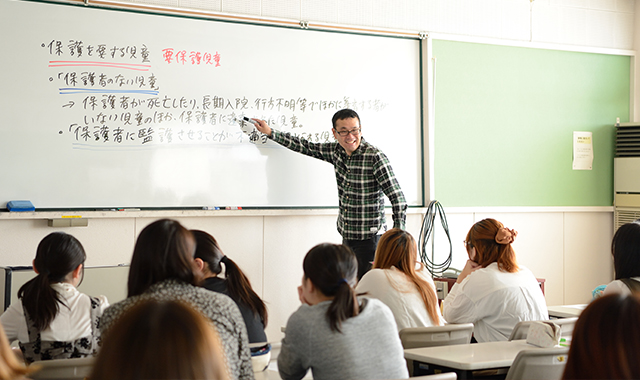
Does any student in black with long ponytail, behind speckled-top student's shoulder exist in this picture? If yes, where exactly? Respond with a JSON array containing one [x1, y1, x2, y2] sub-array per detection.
[[191, 230, 267, 343]]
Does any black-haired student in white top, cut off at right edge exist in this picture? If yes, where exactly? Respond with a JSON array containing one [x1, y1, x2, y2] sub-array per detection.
[[603, 222, 640, 295]]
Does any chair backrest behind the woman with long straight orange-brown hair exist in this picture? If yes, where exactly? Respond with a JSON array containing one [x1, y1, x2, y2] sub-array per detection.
[[400, 323, 473, 348]]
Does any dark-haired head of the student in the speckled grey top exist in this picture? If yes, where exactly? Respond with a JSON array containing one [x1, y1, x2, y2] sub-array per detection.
[[128, 219, 200, 297]]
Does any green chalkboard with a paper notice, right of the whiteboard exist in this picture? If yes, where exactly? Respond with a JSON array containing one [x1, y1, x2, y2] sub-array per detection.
[[433, 40, 630, 207]]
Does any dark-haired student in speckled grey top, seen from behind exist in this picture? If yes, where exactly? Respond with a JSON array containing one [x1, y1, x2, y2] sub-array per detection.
[[100, 219, 253, 379]]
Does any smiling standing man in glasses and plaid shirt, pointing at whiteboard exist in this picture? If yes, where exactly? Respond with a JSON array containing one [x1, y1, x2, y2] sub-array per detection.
[[253, 109, 407, 279]]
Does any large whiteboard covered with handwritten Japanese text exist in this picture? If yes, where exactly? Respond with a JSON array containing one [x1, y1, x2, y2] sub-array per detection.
[[0, 0, 423, 209]]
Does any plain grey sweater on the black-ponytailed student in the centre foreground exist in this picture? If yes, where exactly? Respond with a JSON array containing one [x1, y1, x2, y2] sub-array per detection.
[[278, 298, 409, 380]]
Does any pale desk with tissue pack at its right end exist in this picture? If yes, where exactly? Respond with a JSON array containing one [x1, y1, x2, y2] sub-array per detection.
[[404, 340, 543, 379]]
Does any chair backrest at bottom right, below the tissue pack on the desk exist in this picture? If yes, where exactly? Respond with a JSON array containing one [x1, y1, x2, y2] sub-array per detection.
[[505, 347, 569, 380]]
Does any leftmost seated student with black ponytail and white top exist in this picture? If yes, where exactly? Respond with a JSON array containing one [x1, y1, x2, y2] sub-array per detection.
[[0, 232, 109, 363]]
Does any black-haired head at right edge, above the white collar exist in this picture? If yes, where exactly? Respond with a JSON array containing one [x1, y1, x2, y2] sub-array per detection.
[[611, 221, 640, 280]]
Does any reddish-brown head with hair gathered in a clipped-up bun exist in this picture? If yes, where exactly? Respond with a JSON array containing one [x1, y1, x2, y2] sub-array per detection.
[[465, 219, 518, 273]]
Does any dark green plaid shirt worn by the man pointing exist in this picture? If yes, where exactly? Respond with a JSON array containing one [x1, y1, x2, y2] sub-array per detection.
[[271, 130, 407, 240]]
